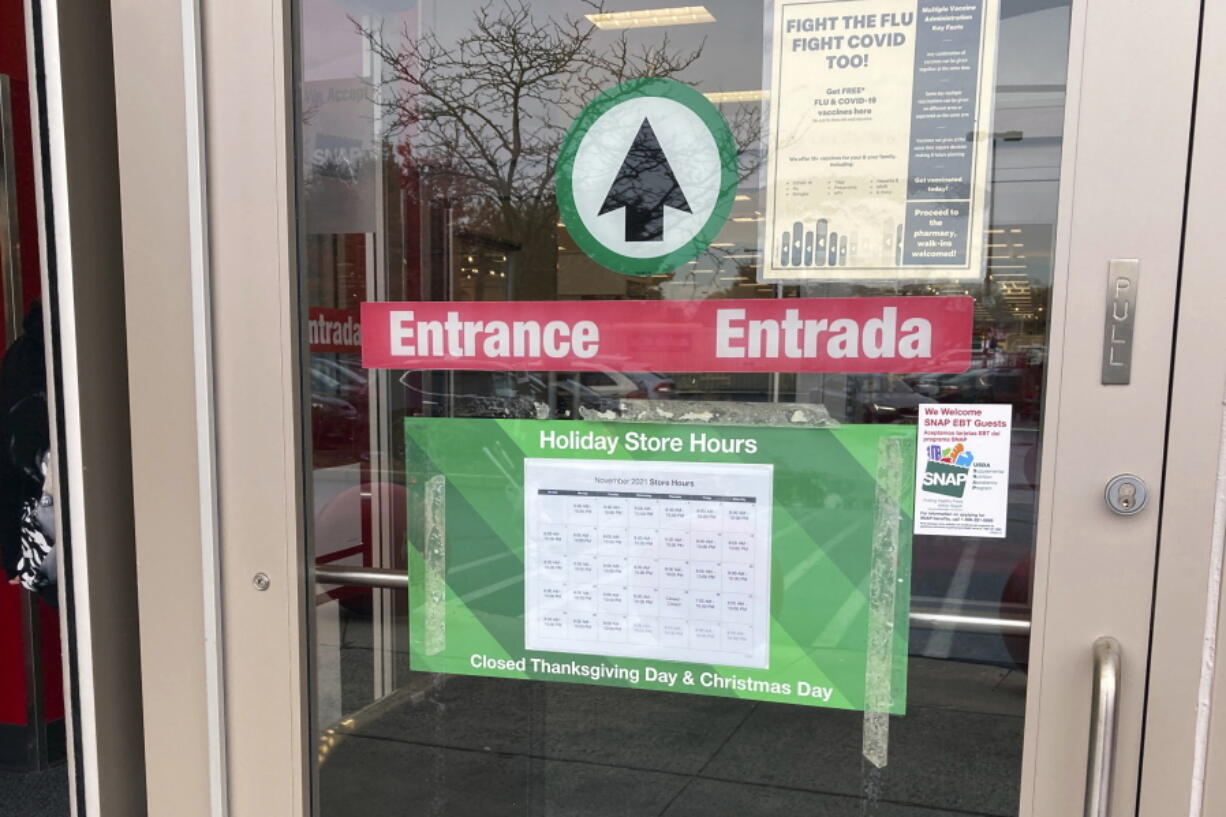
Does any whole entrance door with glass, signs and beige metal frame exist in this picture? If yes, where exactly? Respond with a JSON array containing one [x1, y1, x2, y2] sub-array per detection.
[[198, 0, 1197, 817]]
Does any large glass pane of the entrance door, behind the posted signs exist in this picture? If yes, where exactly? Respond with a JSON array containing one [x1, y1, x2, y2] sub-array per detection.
[[299, 0, 1054, 815]]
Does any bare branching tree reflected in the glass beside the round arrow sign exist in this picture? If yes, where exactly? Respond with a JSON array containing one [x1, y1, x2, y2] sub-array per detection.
[[354, 0, 758, 298]]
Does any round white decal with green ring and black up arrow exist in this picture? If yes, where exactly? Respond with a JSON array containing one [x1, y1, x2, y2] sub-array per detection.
[[558, 79, 737, 275]]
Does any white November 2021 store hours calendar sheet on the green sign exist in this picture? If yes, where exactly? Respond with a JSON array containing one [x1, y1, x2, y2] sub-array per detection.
[[524, 458, 774, 669]]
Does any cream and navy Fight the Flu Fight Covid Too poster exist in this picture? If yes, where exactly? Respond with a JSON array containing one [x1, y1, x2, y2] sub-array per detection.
[[759, 0, 998, 282]]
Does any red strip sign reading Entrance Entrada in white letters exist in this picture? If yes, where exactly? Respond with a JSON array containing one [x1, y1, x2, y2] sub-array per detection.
[[362, 297, 975, 373]]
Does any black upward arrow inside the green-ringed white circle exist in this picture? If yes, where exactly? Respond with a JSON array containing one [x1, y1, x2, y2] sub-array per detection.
[[600, 119, 691, 242]]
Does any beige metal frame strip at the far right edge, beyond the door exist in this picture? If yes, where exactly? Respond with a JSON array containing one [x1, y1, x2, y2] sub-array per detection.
[[1139, 0, 1226, 817]]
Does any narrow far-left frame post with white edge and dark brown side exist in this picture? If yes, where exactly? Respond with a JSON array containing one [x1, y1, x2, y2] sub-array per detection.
[[25, 0, 145, 817]]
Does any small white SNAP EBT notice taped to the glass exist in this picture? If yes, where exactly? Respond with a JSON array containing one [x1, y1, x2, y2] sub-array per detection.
[[915, 404, 1013, 539]]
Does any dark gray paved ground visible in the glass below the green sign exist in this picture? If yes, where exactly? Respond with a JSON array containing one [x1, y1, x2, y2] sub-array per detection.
[[320, 659, 1025, 817]]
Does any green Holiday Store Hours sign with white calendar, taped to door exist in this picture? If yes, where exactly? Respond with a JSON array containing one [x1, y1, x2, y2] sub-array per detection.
[[405, 418, 915, 714]]
